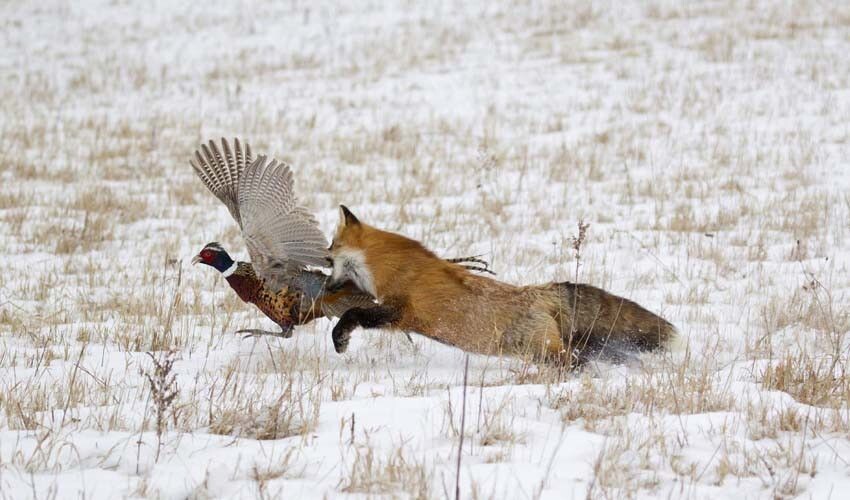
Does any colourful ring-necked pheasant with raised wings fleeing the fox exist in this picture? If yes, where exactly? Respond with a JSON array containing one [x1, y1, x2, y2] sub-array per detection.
[[190, 139, 492, 338]]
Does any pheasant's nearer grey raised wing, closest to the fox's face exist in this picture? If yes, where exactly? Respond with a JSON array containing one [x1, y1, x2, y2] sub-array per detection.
[[236, 155, 328, 291]]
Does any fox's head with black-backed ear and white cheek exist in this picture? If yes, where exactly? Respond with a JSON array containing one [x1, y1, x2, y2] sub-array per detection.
[[327, 205, 378, 298]]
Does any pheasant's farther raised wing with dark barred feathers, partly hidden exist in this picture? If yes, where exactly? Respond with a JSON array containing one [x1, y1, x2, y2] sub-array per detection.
[[189, 138, 253, 228]]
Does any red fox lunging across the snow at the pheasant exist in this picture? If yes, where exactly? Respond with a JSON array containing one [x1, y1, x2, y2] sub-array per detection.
[[328, 205, 676, 366]]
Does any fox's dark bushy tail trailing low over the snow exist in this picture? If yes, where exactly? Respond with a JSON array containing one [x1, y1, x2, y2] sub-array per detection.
[[557, 282, 677, 360]]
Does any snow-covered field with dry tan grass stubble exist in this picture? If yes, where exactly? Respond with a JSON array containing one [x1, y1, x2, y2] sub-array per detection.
[[0, 0, 850, 499]]
